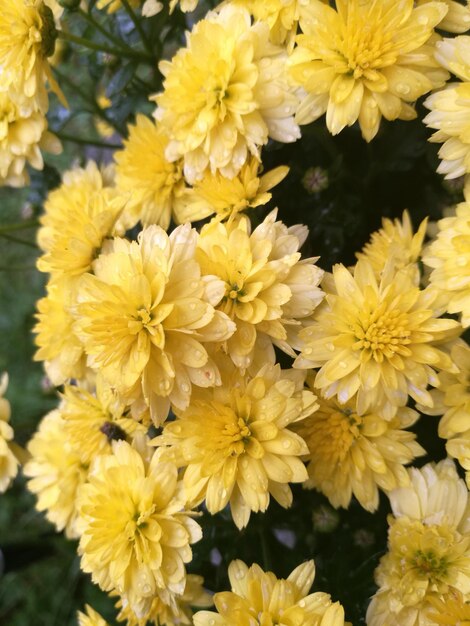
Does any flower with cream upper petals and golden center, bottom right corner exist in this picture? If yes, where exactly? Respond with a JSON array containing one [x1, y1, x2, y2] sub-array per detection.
[[366, 460, 470, 626]]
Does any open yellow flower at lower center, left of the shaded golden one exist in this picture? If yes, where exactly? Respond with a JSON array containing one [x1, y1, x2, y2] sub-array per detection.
[[152, 364, 317, 528]]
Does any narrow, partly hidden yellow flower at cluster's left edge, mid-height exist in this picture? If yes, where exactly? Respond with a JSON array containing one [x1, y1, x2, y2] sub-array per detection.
[[33, 279, 85, 385]]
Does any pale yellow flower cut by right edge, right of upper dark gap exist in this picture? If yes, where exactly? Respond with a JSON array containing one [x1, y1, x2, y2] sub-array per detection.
[[423, 36, 470, 178]]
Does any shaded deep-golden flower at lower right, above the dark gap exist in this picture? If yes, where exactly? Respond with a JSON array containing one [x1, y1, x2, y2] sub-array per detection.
[[295, 372, 426, 511]]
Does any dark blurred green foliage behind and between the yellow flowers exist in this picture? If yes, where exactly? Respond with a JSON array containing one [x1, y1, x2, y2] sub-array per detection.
[[0, 2, 459, 626]]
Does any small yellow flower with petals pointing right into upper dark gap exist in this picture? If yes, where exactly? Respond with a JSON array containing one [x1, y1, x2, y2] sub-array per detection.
[[175, 157, 289, 222]]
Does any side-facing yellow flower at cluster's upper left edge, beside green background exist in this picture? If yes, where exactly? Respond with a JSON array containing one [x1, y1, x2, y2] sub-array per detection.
[[37, 161, 115, 254]]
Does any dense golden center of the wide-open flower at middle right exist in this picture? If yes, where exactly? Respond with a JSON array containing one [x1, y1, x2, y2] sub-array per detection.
[[353, 310, 411, 362]]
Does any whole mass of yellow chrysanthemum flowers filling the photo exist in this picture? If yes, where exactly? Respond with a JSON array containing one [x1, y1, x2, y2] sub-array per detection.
[[0, 0, 470, 626]]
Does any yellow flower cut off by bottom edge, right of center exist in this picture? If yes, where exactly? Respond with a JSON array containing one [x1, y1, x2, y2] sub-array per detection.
[[194, 561, 348, 626]]
